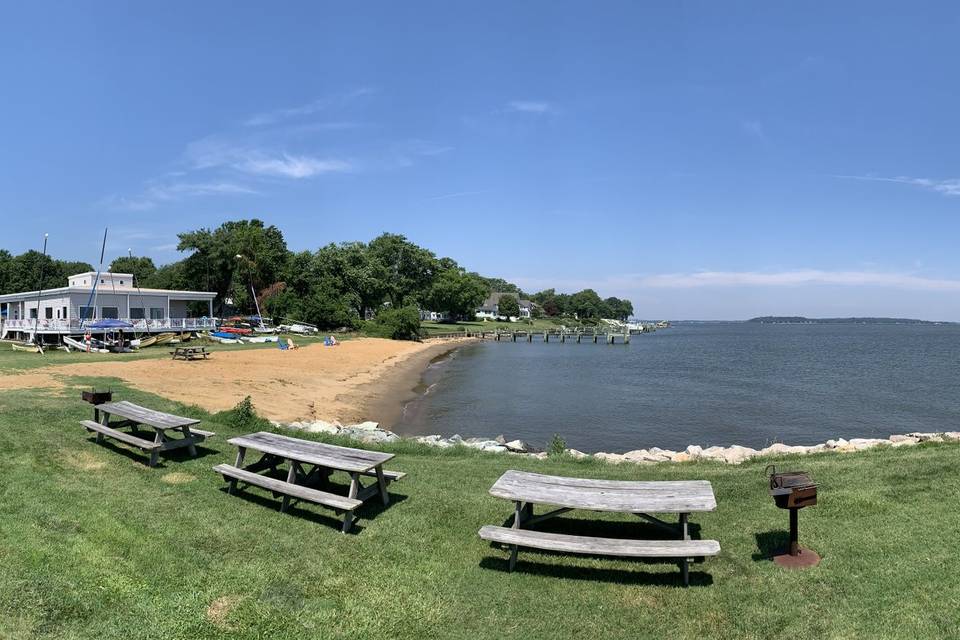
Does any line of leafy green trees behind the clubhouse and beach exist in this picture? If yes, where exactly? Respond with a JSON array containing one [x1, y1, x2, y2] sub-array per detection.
[[0, 219, 633, 329]]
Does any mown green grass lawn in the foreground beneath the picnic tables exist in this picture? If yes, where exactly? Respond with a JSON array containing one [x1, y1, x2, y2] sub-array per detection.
[[0, 378, 960, 640]]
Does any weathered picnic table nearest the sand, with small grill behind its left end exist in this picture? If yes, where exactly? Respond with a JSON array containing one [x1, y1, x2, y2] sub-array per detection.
[[80, 401, 216, 467]]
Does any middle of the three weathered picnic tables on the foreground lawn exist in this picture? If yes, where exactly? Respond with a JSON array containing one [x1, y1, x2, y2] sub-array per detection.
[[213, 431, 406, 533]]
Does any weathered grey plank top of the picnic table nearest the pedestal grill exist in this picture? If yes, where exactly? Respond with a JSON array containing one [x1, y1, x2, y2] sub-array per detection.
[[490, 470, 717, 513]]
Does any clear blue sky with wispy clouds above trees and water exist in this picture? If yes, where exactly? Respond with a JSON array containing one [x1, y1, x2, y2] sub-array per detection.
[[0, 1, 960, 320]]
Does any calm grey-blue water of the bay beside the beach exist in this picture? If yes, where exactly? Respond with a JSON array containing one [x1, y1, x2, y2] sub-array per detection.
[[395, 323, 960, 452]]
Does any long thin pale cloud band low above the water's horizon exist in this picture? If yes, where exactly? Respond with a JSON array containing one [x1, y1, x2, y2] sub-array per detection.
[[626, 269, 960, 291]]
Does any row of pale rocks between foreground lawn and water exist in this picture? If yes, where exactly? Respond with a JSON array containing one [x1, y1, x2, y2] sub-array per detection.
[[273, 420, 960, 464]]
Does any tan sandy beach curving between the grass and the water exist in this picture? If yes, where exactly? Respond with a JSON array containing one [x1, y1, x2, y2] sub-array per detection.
[[0, 338, 472, 425]]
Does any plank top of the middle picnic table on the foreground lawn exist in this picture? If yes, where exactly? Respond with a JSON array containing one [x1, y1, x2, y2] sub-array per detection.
[[227, 431, 393, 473]]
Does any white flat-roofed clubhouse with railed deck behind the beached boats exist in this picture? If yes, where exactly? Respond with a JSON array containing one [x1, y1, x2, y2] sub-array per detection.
[[0, 271, 217, 342]]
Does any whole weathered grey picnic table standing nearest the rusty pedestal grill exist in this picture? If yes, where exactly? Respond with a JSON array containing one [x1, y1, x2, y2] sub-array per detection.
[[480, 470, 720, 586]]
